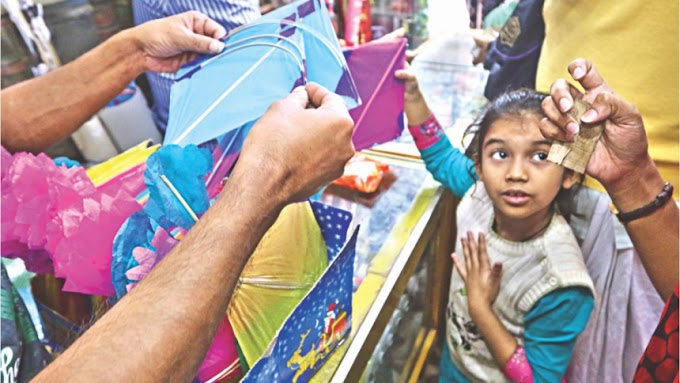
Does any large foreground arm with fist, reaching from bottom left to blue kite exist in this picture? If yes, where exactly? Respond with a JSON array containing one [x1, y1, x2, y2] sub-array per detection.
[[30, 84, 354, 382]]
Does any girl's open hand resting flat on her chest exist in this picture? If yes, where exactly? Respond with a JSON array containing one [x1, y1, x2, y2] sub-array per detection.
[[451, 231, 503, 320]]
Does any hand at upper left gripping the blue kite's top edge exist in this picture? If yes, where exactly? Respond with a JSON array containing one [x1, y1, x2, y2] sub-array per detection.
[[125, 11, 226, 72]]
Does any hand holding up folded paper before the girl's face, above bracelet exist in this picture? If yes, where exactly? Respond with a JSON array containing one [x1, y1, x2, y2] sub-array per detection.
[[541, 59, 660, 190]]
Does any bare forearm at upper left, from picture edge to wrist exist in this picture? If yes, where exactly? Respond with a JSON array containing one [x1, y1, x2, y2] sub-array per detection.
[[2, 31, 144, 152]]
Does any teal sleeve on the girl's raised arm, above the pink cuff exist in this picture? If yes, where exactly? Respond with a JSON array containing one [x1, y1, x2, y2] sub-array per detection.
[[420, 135, 477, 197]]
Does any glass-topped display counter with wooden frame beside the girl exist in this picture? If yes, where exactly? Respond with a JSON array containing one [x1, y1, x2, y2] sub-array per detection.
[[306, 34, 488, 383]]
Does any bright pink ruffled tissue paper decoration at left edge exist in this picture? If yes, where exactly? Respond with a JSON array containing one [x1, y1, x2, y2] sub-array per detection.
[[0, 148, 141, 296]]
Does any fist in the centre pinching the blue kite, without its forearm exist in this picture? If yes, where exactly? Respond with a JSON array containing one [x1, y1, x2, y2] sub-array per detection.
[[230, 83, 354, 204]]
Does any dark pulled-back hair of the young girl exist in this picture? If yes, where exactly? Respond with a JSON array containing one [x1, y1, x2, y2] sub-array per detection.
[[463, 88, 583, 219]]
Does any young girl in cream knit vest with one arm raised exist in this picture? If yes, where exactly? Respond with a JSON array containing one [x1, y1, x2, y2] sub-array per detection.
[[396, 70, 593, 382]]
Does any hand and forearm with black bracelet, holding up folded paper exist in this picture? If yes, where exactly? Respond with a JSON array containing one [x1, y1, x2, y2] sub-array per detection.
[[541, 59, 680, 300]]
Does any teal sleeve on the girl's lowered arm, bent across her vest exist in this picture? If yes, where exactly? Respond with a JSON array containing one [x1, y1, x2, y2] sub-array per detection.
[[524, 287, 594, 383]]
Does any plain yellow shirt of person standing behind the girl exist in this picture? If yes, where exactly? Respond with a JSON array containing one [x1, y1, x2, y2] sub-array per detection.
[[536, 0, 680, 192]]
